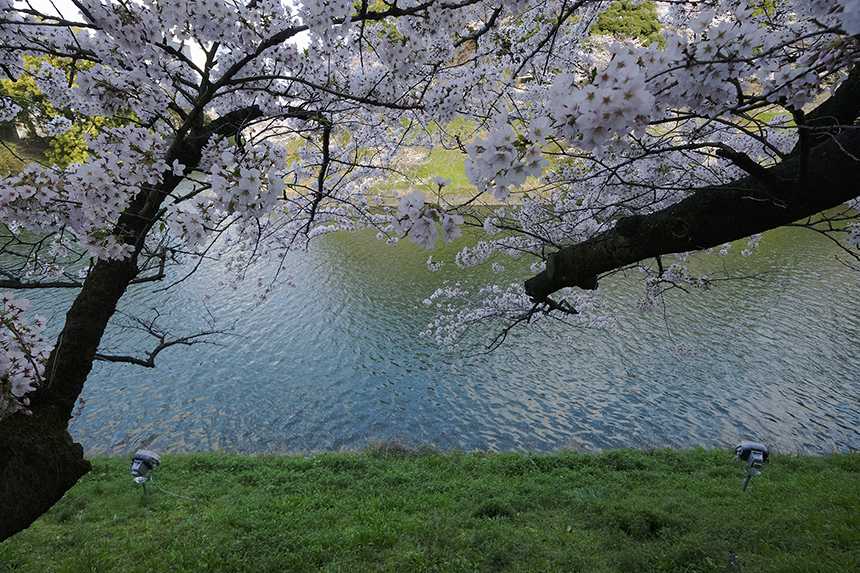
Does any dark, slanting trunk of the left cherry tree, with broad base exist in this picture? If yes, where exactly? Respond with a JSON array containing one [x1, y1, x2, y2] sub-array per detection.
[[0, 104, 262, 541]]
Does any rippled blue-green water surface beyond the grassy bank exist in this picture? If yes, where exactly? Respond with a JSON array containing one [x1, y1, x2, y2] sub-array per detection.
[[26, 226, 860, 454]]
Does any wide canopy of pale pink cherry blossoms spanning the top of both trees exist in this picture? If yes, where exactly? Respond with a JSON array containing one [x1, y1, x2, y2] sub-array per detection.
[[0, 0, 860, 386]]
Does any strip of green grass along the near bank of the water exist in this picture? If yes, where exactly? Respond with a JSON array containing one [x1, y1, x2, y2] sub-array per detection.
[[0, 444, 860, 573]]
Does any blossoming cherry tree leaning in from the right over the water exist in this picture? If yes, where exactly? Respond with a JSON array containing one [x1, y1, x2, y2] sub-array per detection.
[[412, 2, 860, 352]]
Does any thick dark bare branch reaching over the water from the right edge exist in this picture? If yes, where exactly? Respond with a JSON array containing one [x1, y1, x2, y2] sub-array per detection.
[[525, 128, 860, 302]]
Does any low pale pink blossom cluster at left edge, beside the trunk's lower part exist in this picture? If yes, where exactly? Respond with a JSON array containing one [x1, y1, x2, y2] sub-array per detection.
[[0, 293, 53, 420]]
